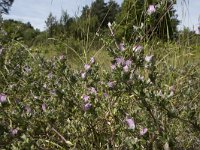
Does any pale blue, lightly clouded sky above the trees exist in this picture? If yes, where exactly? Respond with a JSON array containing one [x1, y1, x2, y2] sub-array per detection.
[[3, 0, 200, 32]]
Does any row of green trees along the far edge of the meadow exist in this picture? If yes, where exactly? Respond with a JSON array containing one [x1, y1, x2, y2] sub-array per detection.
[[0, 0, 198, 46]]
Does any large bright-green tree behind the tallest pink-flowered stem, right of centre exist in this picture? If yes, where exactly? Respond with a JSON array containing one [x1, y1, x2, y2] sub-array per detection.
[[117, 0, 179, 40]]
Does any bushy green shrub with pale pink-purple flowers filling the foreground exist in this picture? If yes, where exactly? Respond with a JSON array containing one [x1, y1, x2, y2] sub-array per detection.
[[0, 2, 200, 150]]
